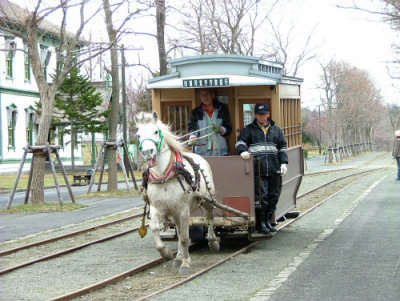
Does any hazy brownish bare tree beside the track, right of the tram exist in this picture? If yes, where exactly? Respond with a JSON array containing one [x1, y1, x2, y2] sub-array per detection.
[[320, 61, 382, 146]]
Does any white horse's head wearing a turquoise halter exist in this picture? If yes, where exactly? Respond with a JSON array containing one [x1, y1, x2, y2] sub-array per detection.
[[135, 112, 163, 167]]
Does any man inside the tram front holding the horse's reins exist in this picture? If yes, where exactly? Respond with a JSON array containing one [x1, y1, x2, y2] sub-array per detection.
[[188, 88, 232, 156]]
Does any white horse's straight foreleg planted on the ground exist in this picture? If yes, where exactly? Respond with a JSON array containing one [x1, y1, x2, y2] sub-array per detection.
[[177, 208, 190, 276]]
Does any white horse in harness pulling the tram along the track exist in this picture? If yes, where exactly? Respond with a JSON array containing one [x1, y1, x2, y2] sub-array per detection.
[[135, 113, 219, 275]]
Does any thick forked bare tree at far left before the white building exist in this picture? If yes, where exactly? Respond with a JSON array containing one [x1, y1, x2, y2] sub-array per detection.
[[0, 0, 103, 204]]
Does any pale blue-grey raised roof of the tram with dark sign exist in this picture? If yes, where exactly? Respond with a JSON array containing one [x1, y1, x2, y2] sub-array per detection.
[[147, 54, 303, 89]]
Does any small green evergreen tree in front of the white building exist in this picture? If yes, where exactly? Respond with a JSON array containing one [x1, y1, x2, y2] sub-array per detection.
[[54, 68, 109, 170]]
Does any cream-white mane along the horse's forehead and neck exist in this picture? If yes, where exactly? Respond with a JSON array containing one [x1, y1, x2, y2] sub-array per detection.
[[136, 112, 184, 153]]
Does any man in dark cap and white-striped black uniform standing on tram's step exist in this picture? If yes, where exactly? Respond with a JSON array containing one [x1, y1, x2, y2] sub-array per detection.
[[235, 104, 288, 235]]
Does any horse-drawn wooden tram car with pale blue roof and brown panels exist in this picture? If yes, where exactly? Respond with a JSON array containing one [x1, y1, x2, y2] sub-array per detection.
[[147, 54, 304, 240]]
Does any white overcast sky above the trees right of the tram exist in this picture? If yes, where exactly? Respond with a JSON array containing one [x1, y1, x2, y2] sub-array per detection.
[[284, 0, 400, 107]]
